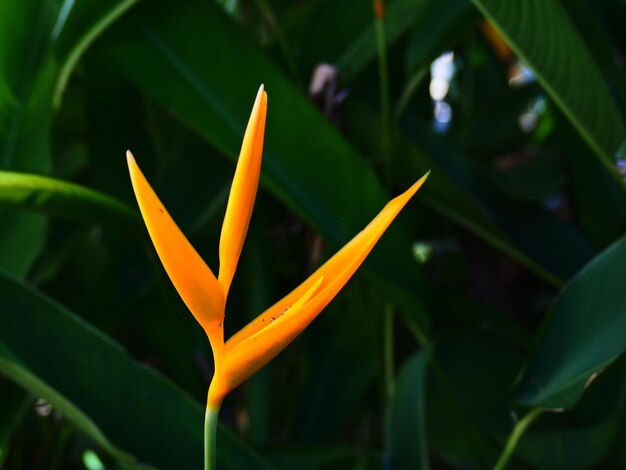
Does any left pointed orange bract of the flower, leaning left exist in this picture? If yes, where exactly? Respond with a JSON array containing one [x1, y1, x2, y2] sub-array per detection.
[[126, 151, 224, 356]]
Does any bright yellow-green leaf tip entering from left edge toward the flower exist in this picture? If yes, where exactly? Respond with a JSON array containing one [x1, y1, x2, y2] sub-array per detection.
[[0, 171, 143, 234]]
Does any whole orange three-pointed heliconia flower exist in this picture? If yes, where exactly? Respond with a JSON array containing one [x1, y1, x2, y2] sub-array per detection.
[[127, 85, 428, 410]]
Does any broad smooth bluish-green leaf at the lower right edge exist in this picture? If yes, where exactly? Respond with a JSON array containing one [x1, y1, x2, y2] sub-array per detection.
[[515, 238, 626, 408]]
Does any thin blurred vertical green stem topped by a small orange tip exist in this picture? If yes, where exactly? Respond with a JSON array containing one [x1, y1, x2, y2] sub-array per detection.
[[374, 2, 393, 185]]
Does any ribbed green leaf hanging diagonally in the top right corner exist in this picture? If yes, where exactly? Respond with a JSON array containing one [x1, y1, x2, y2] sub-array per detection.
[[472, 0, 626, 188]]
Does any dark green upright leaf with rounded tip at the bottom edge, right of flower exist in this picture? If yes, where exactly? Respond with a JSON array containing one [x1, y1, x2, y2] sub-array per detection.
[[385, 350, 430, 469]]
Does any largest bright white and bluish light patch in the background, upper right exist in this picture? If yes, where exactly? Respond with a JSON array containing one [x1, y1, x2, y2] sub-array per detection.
[[428, 51, 456, 133]]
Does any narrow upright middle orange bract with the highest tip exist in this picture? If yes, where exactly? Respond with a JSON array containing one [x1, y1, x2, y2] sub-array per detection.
[[218, 85, 267, 298]]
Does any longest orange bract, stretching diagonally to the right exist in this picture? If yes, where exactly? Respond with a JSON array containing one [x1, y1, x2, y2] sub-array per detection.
[[214, 173, 428, 396]]
